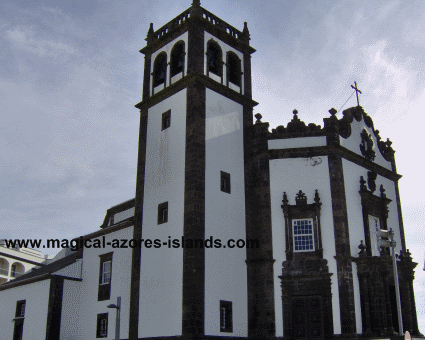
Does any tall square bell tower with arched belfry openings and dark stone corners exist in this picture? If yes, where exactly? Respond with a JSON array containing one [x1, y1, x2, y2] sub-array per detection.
[[129, 0, 274, 339]]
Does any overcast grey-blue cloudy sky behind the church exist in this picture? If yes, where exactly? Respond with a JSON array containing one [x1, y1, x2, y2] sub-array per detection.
[[0, 0, 425, 333]]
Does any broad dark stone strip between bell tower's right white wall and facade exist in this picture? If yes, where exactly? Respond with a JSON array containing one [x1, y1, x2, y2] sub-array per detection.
[[244, 119, 276, 339]]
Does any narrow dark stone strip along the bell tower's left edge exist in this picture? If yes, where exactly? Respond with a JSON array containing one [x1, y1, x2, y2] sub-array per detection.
[[128, 108, 148, 339]]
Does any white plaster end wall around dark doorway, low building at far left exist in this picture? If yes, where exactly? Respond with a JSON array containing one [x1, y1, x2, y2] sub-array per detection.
[[0, 279, 50, 340]]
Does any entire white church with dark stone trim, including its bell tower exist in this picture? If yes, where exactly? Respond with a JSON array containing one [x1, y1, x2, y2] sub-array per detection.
[[0, 0, 423, 340]]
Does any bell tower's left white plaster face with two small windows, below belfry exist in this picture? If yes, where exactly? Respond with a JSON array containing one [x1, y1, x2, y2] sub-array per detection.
[[139, 89, 187, 337]]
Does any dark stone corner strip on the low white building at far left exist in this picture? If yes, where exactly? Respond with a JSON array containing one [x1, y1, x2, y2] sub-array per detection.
[[46, 276, 64, 340]]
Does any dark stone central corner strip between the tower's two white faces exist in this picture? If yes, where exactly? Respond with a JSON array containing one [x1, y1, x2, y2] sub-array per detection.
[[182, 82, 206, 338]]
